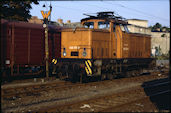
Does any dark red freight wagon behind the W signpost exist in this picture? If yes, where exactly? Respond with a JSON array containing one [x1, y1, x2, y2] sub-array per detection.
[[0, 19, 61, 78]]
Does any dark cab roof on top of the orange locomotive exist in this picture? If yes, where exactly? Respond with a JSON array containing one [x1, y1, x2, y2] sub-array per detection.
[[81, 11, 128, 24]]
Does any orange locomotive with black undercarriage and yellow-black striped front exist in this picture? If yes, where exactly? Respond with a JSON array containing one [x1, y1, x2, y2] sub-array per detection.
[[54, 12, 154, 81]]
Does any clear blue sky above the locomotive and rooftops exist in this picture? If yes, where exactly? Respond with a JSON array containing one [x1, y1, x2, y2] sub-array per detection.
[[30, 0, 170, 27]]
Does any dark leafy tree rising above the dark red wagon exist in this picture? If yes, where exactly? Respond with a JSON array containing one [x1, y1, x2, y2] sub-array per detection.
[[0, 0, 39, 21]]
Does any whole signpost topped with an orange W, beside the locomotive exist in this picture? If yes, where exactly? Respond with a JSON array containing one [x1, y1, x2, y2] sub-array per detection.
[[41, 7, 51, 79]]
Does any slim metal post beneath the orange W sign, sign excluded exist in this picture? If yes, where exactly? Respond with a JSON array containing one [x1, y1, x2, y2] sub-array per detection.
[[45, 21, 49, 79]]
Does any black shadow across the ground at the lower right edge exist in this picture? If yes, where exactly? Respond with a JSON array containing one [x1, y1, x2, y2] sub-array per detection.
[[142, 78, 171, 111]]
